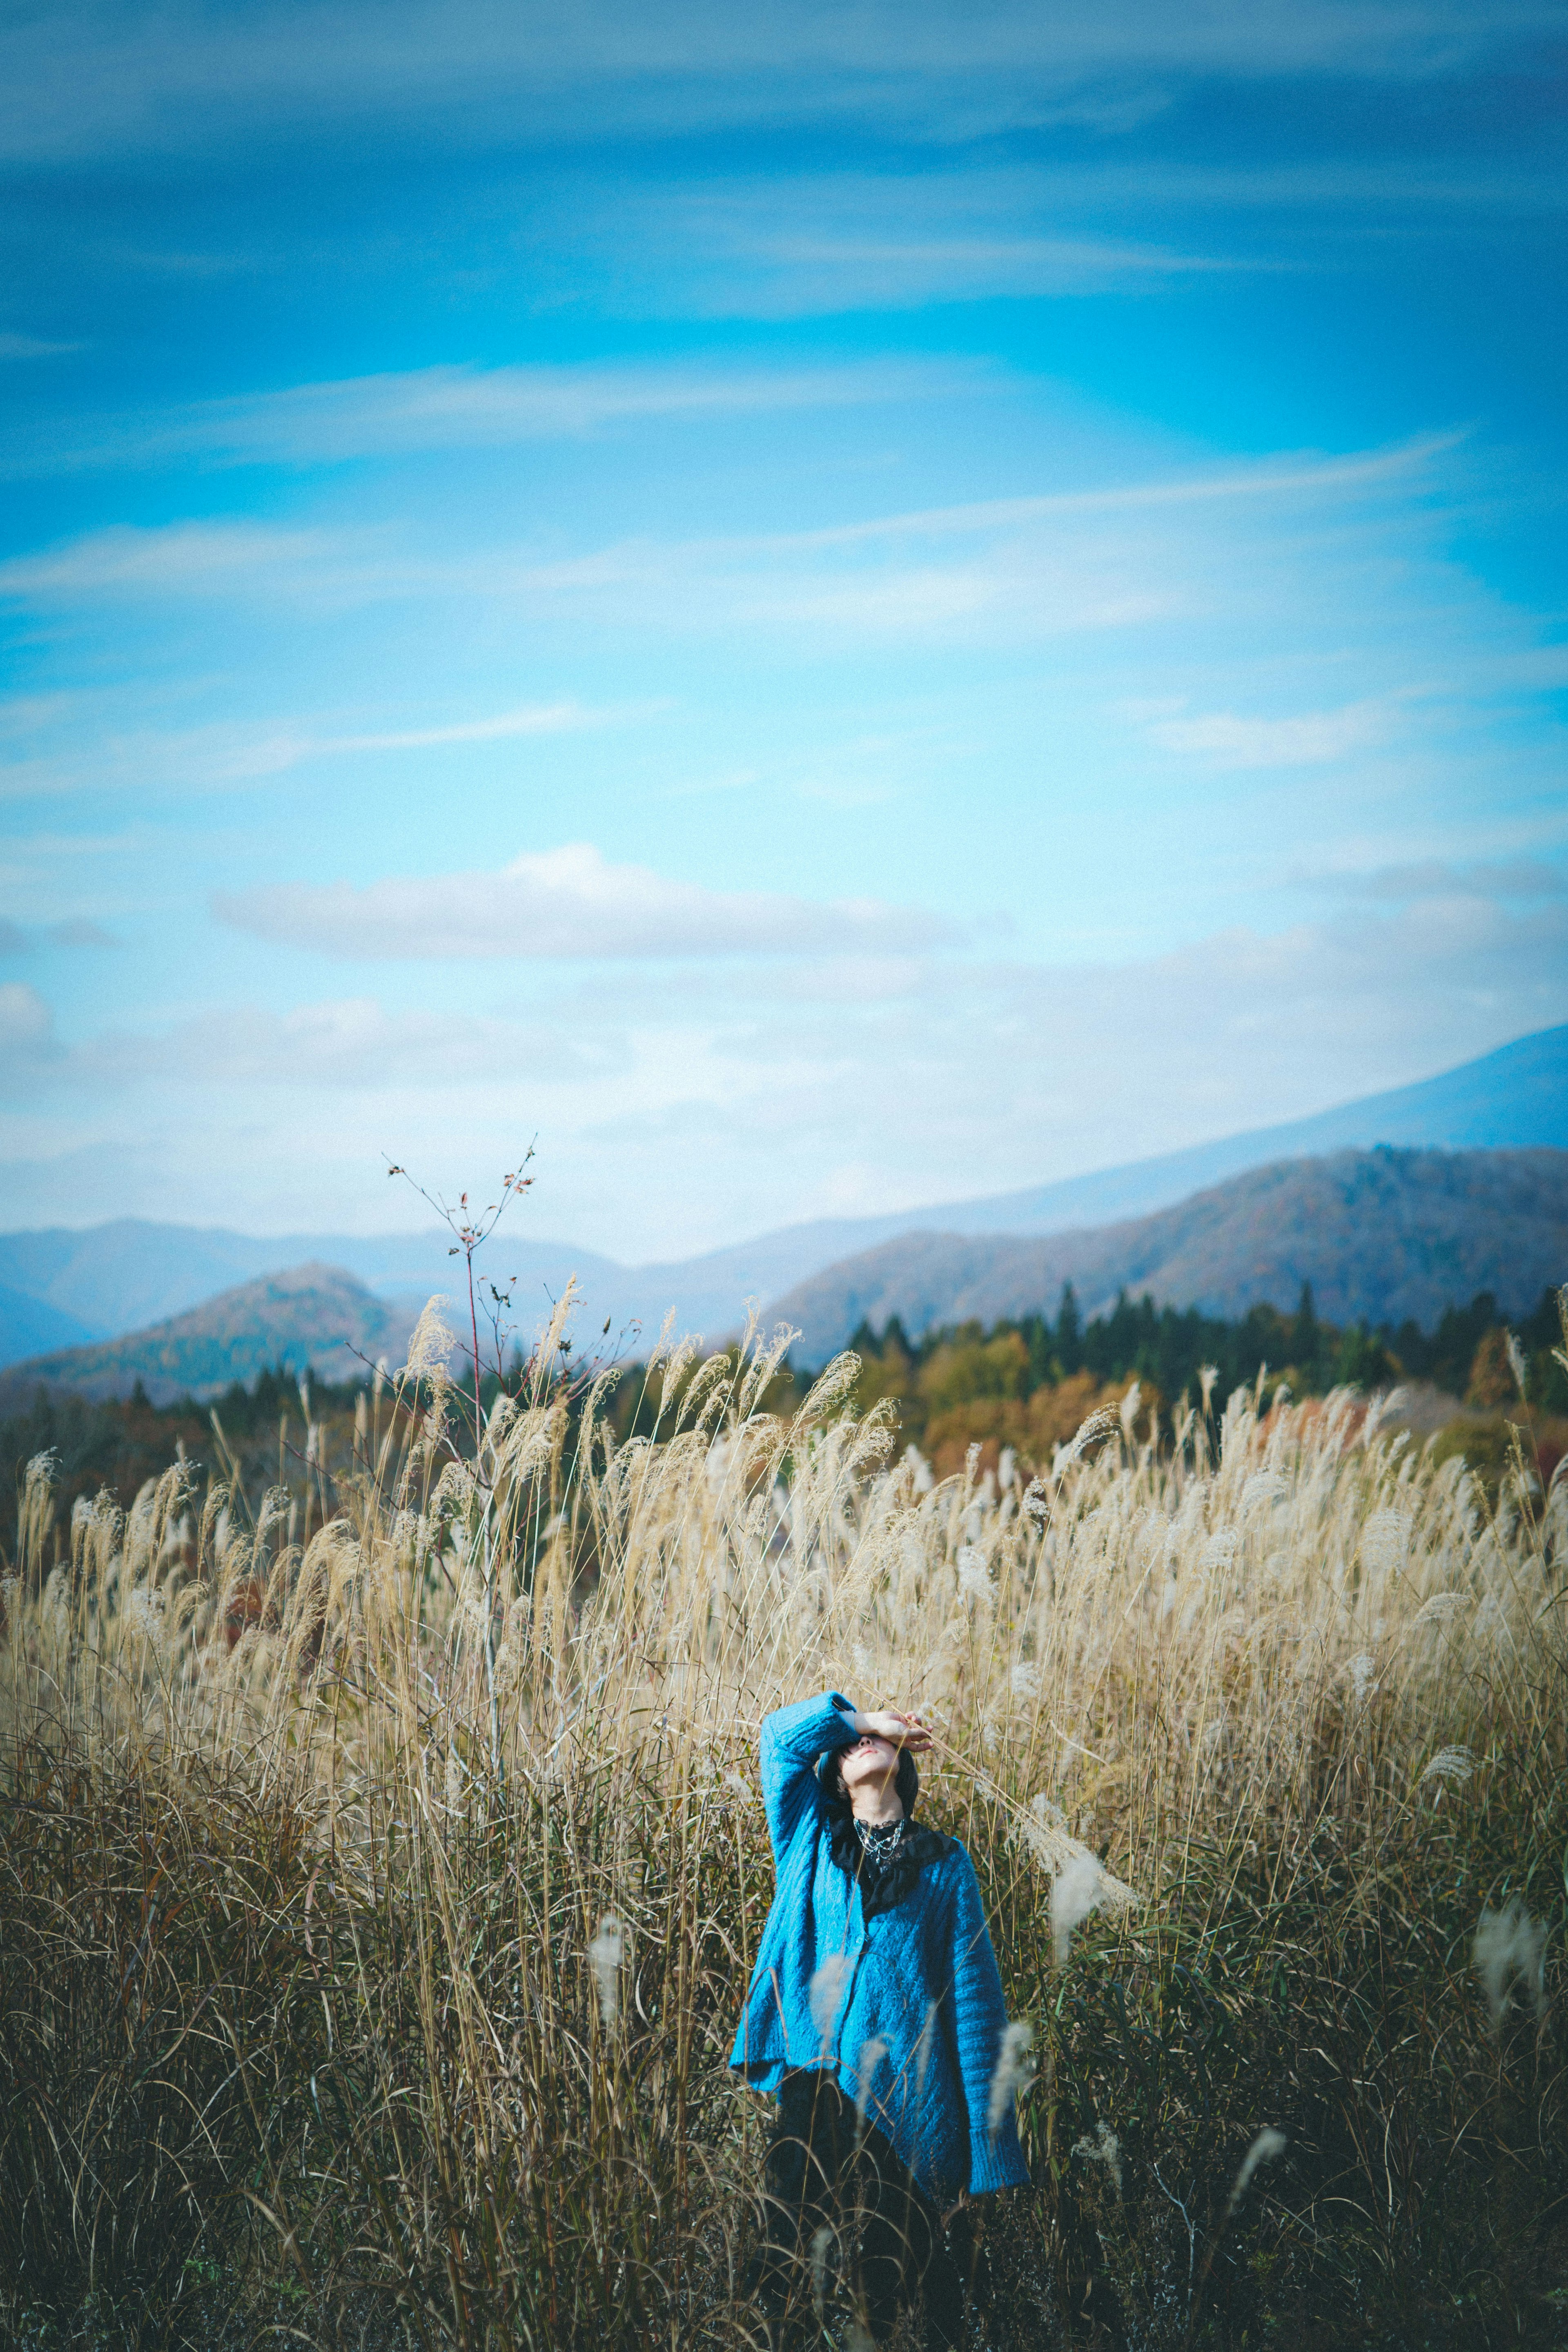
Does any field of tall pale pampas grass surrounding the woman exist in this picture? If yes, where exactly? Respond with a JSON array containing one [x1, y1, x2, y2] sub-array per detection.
[[0, 1322, 1568, 2352]]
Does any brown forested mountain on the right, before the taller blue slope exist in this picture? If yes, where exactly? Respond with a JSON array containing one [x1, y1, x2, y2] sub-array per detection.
[[769, 1145, 1568, 1362]]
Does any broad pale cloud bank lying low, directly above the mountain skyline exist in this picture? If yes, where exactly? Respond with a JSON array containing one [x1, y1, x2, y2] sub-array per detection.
[[0, 901, 1568, 1261]]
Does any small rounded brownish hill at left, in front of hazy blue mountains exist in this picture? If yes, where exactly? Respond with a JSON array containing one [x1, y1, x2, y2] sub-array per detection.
[[0, 1265, 423, 1404]]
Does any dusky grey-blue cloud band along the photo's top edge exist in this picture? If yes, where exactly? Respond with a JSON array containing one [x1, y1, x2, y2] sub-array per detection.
[[0, 0, 1559, 158]]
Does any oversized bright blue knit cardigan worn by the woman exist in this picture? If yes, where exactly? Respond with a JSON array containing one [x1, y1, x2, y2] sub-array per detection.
[[729, 1691, 1030, 2199]]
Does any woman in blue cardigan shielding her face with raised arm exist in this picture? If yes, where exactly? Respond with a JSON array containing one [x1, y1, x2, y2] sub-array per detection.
[[729, 1691, 1030, 2347]]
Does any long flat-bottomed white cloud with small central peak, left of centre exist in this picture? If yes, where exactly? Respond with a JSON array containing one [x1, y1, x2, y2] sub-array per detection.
[[214, 842, 943, 962]]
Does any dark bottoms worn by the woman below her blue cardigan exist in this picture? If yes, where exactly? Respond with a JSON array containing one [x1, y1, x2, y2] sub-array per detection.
[[752, 2070, 976, 2352]]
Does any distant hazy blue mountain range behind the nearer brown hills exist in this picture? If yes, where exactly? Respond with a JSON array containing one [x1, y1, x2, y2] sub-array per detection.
[[0, 1025, 1568, 1367]]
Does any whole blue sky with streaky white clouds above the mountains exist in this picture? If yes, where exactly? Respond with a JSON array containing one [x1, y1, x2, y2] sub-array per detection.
[[0, 0, 1568, 1258]]
